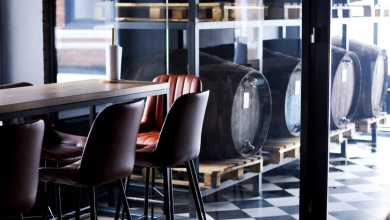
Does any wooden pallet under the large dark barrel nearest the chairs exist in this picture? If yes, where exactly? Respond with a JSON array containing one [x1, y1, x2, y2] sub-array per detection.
[[132, 155, 263, 188]]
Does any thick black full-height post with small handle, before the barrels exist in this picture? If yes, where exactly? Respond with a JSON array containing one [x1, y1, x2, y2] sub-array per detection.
[[299, 0, 331, 220]]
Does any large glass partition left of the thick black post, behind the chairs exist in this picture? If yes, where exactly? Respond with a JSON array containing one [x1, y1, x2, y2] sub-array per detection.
[[56, 0, 302, 219]]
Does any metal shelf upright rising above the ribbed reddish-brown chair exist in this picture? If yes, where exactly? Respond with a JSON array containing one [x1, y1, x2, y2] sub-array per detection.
[[187, 0, 199, 76]]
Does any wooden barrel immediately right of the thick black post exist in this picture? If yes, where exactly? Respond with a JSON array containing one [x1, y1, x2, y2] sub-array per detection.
[[330, 46, 362, 129]]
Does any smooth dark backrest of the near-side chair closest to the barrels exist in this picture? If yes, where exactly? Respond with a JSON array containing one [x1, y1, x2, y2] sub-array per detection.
[[153, 91, 209, 167]]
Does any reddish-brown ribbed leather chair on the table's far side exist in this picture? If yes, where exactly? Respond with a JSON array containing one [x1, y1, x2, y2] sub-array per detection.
[[137, 75, 202, 148]]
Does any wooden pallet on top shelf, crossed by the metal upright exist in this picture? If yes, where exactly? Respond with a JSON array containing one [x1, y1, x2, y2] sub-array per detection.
[[115, 3, 231, 21]]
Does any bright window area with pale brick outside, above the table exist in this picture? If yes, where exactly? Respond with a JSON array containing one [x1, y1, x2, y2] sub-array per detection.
[[55, 0, 113, 82]]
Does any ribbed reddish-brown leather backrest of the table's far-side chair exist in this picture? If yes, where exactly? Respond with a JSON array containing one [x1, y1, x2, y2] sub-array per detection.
[[141, 75, 202, 130]]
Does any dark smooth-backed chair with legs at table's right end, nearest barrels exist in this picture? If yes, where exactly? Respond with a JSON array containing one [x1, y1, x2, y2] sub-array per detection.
[[120, 91, 209, 219]]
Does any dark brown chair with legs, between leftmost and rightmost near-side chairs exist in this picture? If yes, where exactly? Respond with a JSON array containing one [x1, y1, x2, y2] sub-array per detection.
[[39, 100, 144, 219]]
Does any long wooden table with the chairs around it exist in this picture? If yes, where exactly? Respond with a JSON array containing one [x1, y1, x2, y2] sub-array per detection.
[[0, 79, 169, 121]]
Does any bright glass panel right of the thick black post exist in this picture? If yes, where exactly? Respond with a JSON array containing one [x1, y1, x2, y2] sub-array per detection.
[[328, 0, 390, 219]]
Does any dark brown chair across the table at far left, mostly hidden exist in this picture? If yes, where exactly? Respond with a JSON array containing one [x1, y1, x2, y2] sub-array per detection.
[[0, 82, 86, 163]]
